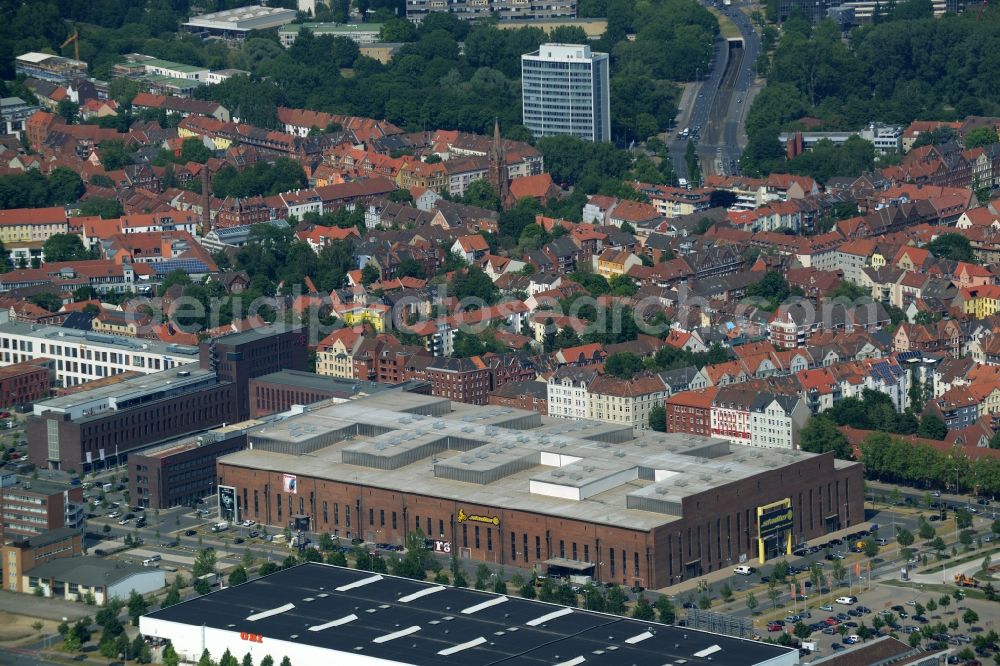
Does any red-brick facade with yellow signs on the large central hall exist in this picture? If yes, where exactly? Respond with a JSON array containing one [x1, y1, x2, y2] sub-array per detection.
[[223, 454, 864, 588]]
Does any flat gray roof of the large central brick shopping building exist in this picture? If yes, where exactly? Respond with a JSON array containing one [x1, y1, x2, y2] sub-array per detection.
[[220, 392, 836, 530]]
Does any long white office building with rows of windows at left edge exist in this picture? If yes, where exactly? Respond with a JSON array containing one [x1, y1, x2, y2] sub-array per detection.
[[0, 321, 198, 387]]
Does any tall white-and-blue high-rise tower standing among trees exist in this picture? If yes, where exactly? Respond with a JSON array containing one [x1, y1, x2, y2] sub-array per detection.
[[521, 44, 611, 141]]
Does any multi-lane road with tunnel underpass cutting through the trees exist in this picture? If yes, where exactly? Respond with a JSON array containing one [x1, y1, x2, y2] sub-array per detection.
[[670, 3, 761, 178]]
